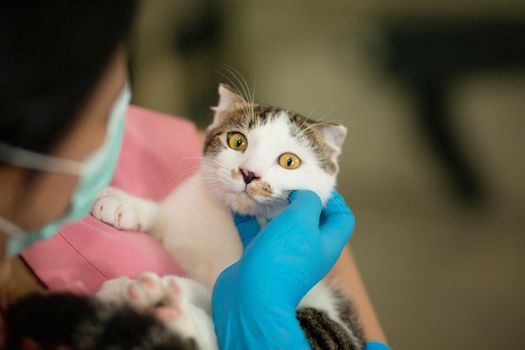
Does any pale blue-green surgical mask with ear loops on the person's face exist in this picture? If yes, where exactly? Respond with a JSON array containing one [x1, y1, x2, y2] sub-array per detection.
[[0, 86, 131, 256]]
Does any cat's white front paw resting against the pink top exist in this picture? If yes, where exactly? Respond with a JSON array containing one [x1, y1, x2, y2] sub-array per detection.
[[91, 187, 143, 231]]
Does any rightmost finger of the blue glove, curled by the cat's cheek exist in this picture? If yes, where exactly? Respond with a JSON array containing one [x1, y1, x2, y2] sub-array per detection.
[[320, 192, 355, 249]]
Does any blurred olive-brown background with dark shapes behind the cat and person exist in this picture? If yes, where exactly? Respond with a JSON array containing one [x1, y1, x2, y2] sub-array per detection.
[[131, 0, 525, 350]]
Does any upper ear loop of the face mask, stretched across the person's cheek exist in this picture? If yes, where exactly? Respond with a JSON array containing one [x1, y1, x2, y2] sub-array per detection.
[[0, 142, 84, 175]]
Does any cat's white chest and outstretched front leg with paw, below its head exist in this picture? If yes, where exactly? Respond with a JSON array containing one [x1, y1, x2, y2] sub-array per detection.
[[93, 171, 242, 288]]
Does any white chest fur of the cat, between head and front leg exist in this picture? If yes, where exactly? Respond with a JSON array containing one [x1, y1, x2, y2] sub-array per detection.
[[151, 172, 242, 288]]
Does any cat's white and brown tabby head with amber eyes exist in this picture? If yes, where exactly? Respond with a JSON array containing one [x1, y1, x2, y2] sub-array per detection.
[[202, 85, 346, 218]]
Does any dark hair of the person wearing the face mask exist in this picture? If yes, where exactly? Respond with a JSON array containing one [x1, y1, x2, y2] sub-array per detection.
[[0, 0, 135, 157]]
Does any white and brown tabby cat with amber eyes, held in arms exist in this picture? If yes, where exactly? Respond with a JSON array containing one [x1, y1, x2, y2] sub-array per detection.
[[4, 85, 364, 350]]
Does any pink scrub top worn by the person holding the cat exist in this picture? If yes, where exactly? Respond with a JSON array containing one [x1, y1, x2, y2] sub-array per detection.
[[22, 106, 201, 293]]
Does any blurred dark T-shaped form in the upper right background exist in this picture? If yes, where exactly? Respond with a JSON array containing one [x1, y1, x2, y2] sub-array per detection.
[[385, 19, 525, 204]]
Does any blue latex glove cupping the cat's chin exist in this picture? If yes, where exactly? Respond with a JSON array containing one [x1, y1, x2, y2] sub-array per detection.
[[212, 191, 354, 350]]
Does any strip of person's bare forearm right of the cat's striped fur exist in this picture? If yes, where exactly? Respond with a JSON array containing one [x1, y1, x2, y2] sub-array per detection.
[[327, 246, 387, 343]]
